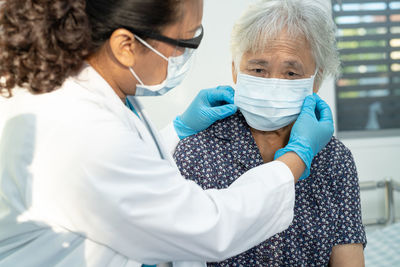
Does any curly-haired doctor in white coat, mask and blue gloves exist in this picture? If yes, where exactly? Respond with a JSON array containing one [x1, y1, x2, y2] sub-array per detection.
[[0, 0, 333, 267]]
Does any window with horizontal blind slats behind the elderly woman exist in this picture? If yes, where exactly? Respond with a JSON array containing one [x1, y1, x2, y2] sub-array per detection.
[[332, 0, 400, 132]]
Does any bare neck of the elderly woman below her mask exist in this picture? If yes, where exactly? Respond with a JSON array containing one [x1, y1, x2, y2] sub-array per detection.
[[250, 124, 293, 163]]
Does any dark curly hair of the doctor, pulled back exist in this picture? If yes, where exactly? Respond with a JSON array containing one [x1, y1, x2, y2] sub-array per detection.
[[0, 0, 180, 97]]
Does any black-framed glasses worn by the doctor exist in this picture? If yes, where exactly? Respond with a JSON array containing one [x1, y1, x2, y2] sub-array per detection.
[[123, 26, 204, 49]]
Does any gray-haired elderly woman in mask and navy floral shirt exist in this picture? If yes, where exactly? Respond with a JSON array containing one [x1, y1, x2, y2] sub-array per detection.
[[174, 0, 366, 267]]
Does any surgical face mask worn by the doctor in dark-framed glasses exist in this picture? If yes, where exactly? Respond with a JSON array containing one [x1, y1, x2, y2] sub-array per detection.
[[129, 36, 195, 96]]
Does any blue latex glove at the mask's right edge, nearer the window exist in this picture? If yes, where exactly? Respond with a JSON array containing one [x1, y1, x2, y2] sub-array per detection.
[[275, 94, 334, 180]]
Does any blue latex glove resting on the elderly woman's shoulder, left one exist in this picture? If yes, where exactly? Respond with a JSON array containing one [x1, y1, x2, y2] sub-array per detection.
[[174, 86, 237, 139]]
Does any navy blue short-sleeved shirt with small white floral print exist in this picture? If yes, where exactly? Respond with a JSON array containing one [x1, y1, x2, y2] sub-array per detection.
[[174, 112, 366, 267]]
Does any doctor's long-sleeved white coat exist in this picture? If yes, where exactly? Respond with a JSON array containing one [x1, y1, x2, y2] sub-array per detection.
[[0, 66, 294, 267]]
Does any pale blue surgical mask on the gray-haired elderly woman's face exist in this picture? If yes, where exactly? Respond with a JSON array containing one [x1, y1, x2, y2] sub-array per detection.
[[234, 73, 315, 131]]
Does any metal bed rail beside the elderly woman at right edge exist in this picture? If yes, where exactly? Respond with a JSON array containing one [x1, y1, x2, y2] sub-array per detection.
[[360, 179, 400, 226]]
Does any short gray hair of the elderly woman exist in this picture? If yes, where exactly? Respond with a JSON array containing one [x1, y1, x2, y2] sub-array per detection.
[[231, 0, 340, 86]]
